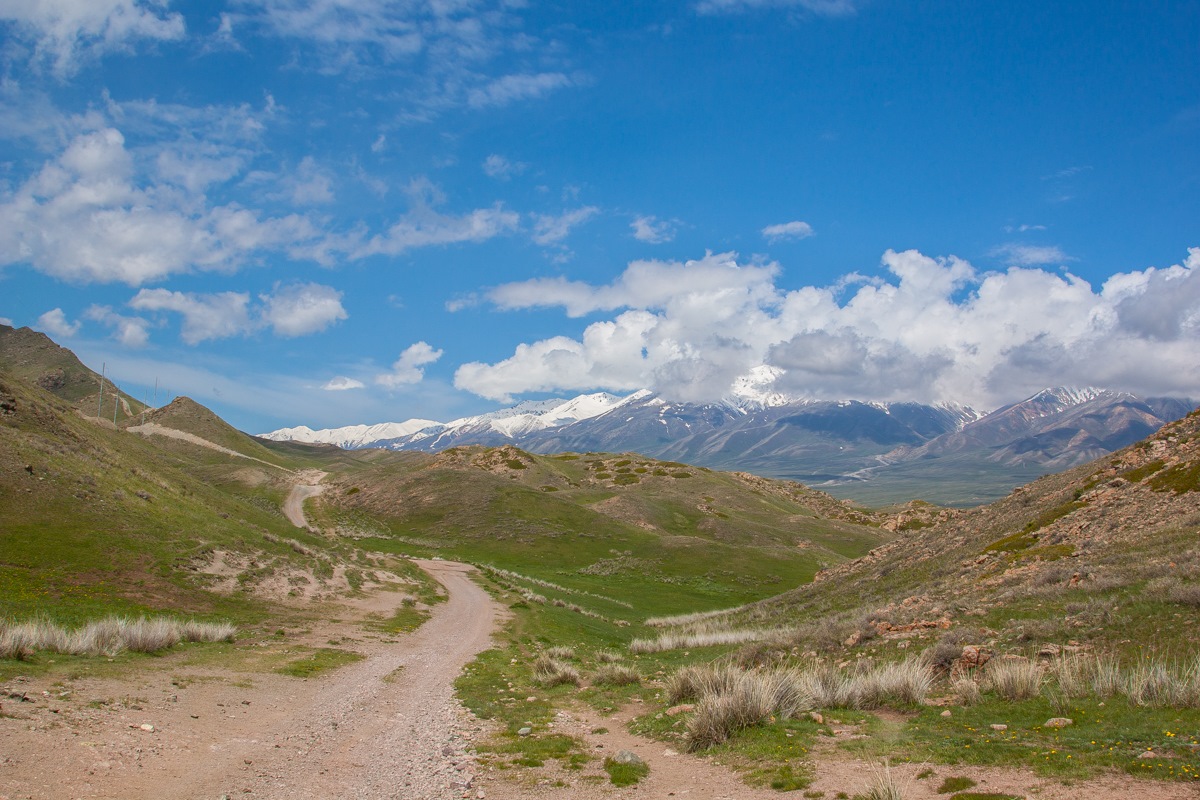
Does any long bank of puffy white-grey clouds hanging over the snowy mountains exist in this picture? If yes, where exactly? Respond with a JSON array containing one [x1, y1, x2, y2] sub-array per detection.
[[455, 248, 1200, 408]]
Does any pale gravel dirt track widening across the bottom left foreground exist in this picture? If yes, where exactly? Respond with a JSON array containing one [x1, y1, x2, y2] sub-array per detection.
[[0, 561, 498, 800]]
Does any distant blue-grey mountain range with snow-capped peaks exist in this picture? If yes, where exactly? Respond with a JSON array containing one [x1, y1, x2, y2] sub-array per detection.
[[260, 387, 1195, 506]]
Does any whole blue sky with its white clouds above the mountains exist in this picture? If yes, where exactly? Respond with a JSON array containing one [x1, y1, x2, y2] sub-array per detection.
[[0, 0, 1200, 432]]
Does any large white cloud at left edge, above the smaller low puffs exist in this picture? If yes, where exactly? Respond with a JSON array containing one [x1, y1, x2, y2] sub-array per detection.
[[0, 128, 320, 285]]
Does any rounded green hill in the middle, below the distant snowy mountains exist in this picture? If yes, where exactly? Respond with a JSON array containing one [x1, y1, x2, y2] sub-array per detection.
[[323, 447, 889, 621]]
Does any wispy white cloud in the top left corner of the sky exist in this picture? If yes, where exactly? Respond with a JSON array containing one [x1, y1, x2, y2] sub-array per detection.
[[0, 0, 185, 78]]
